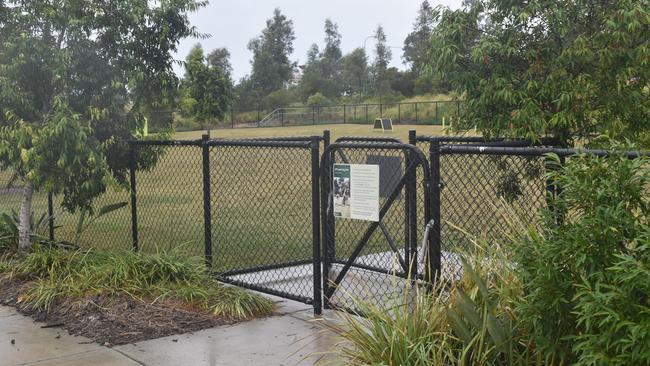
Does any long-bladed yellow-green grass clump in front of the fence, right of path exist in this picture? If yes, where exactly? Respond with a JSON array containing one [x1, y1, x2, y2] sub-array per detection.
[[328, 219, 542, 366]]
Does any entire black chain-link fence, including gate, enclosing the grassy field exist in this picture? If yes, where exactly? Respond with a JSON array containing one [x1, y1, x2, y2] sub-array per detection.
[[0, 131, 638, 313]]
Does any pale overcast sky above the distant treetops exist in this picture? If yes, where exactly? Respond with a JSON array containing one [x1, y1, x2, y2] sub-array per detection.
[[176, 0, 462, 80]]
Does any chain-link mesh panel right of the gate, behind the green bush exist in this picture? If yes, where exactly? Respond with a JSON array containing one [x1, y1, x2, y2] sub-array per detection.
[[440, 154, 547, 278]]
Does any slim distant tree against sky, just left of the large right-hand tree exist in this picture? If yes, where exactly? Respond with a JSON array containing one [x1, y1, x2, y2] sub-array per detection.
[[402, 0, 433, 76]]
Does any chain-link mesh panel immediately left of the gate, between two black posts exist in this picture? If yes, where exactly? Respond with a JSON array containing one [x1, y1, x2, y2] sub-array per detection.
[[210, 142, 313, 300]]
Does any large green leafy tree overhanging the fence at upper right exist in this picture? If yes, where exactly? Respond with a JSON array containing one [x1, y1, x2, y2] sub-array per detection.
[[429, 0, 650, 145]]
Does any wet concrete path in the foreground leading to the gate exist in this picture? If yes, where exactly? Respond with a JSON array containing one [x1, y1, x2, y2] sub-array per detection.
[[0, 298, 336, 366]]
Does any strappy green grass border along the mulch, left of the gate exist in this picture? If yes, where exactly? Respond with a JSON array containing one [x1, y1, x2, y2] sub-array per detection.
[[6, 248, 273, 319]]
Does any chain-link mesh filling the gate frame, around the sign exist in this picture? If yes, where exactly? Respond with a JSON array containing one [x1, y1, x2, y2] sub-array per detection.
[[323, 143, 425, 309]]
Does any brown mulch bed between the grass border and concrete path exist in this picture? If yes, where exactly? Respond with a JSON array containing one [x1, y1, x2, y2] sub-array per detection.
[[0, 279, 258, 346]]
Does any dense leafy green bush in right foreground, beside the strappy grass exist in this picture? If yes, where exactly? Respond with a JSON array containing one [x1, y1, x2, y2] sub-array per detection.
[[516, 150, 650, 365]]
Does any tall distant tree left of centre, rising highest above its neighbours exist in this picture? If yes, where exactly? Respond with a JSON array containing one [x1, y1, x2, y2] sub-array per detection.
[[248, 8, 296, 95]]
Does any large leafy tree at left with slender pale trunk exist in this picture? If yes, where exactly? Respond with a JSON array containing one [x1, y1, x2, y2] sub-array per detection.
[[0, 0, 204, 251]]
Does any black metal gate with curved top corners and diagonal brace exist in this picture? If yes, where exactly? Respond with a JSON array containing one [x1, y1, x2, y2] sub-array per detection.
[[321, 138, 430, 310]]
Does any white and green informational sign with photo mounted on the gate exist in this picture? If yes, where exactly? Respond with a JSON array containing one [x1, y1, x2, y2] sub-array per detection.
[[333, 164, 379, 221]]
